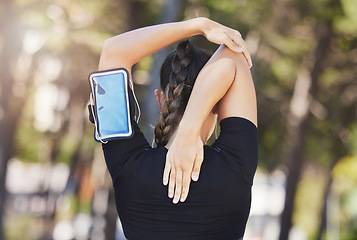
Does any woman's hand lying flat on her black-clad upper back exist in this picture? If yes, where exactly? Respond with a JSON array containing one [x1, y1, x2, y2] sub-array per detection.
[[163, 133, 203, 204]]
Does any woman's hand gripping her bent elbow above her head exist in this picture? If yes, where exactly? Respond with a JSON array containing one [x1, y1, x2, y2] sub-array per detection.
[[200, 18, 253, 67]]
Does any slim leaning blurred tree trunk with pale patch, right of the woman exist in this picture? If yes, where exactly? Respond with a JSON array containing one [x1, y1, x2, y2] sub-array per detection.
[[279, 22, 332, 240]]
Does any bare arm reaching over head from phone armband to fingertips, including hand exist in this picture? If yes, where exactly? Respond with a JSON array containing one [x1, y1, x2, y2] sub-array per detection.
[[99, 18, 251, 72]]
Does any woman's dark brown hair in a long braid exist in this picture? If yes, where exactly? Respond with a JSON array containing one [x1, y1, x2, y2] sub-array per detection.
[[154, 40, 210, 146]]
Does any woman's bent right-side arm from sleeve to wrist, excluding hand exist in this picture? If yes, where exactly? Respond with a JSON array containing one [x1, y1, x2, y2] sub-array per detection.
[[179, 46, 257, 127]]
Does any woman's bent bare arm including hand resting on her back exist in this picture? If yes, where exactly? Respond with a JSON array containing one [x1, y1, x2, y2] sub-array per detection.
[[163, 46, 257, 203]]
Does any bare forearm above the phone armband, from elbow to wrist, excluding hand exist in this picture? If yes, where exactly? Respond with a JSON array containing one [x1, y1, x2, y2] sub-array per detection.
[[99, 18, 210, 70]]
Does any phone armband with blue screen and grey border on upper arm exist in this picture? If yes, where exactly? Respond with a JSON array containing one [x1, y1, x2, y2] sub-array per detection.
[[89, 68, 140, 143]]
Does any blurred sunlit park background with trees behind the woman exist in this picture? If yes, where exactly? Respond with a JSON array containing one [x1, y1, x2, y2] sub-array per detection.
[[0, 0, 357, 240]]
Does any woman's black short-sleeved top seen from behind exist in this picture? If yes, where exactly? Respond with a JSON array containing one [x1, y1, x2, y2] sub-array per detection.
[[103, 117, 258, 240]]
